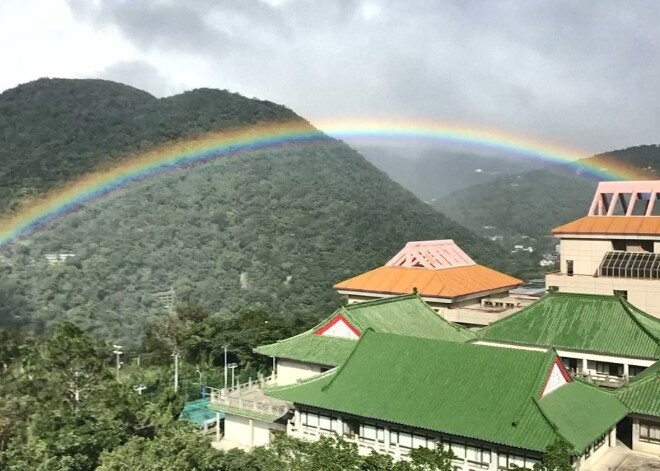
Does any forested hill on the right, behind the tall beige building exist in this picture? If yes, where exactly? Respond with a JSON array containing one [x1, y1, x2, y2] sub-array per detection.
[[434, 145, 660, 260]]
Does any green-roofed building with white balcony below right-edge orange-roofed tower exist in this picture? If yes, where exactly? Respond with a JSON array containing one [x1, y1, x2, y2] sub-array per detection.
[[475, 292, 660, 387]]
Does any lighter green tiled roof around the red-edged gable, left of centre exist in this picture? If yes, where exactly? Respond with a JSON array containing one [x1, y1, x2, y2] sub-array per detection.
[[254, 294, 476, 366]]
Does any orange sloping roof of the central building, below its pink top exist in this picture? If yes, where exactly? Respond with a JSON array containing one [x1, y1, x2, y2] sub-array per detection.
[[334, 264, 522, 298]]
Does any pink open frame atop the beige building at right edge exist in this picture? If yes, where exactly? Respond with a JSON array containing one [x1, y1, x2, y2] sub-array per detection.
[[588, 180, 660, 216]]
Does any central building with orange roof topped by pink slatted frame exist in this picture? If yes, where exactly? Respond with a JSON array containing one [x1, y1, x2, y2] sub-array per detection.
[[334, 240, 531, 327]]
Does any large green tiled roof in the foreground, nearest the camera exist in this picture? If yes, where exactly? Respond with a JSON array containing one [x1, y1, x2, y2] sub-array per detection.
[[269, 330, 628, 452]]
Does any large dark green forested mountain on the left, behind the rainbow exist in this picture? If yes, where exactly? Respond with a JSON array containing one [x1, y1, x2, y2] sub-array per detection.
[[0, 80, 516, 344]]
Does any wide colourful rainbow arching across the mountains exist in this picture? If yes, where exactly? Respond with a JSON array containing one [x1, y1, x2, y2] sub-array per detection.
[[0, 120, 636, 248]]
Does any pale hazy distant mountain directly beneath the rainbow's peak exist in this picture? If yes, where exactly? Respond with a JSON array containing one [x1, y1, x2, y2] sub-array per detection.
[[356, 146, 540, 203]]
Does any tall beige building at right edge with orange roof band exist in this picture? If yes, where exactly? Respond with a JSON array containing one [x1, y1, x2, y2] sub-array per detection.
[[546, 181, 660, 317]]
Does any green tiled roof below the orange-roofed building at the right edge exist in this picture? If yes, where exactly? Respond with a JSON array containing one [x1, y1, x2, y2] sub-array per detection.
[[477, 293, 660, 359]]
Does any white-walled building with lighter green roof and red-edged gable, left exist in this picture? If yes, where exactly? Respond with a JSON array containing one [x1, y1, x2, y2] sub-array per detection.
[[254, 294, 476, 385]]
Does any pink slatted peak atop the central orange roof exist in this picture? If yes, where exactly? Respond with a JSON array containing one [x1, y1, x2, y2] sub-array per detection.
[[385, 239, 476, 270]]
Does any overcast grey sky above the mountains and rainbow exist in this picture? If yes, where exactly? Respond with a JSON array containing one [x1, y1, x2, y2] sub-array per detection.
[[0, 0, 660, 153]]
